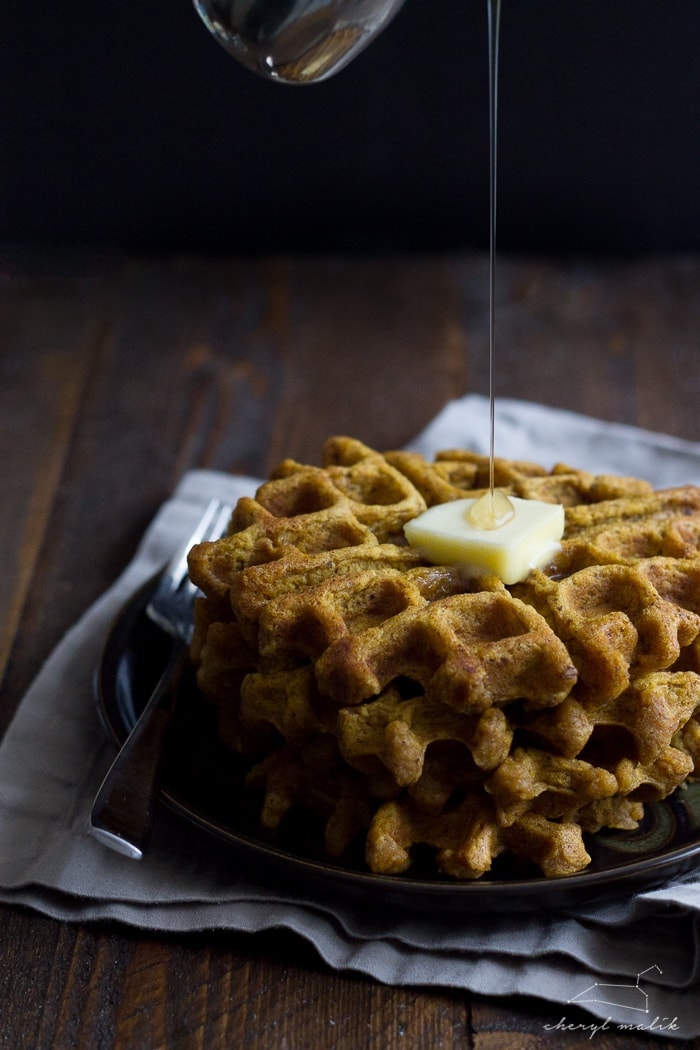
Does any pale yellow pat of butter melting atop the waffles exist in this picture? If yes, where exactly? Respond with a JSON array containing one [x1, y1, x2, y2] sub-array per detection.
[[404, 496, 565, 584]]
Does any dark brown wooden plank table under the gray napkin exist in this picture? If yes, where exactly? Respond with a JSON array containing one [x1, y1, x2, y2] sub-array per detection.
[[0, 250, 700, 1050]]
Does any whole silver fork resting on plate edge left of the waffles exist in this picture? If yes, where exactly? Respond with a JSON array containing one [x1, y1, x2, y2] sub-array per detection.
[[88, 500, 231, 860]]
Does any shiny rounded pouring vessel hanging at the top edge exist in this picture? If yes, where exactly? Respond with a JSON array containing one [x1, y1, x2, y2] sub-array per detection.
[[194, 0, 411, 84]]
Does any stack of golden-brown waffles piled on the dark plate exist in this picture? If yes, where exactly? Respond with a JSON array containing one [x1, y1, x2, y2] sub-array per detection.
[[190, 438, 700, 879]]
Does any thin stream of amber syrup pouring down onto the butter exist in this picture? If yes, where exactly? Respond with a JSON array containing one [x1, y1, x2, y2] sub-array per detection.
[[469, 0, 515, 529]]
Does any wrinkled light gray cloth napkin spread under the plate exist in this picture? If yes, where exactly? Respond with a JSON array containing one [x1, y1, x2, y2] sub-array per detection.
[[0, 396, 700, 1038]]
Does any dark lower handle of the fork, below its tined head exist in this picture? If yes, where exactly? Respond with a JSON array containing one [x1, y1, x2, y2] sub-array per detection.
[[88, 642, 188, 860]]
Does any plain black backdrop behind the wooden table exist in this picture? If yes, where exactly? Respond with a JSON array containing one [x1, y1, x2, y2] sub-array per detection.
[[0, 0, 700, 253]]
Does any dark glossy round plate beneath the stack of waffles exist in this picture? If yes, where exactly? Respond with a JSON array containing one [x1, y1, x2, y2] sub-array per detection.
[[97, 582, 700, 910]]
